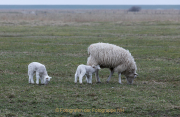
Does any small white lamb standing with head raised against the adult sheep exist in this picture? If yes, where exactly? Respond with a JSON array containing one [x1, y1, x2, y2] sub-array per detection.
[[74, 64, 101, 83]]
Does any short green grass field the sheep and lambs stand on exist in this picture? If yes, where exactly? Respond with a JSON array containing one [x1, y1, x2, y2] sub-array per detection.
[[0, 21, 180, 117]]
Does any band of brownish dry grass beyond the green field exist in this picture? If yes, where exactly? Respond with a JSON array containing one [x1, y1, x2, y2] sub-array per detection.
[[0, 9, 180, 26]]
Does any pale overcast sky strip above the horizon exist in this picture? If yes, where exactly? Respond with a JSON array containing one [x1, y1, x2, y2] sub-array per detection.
[[0, 0, 180, 5]]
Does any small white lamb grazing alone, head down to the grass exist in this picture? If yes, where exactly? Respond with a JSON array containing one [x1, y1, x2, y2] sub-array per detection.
[[28, 62, 52, 84]]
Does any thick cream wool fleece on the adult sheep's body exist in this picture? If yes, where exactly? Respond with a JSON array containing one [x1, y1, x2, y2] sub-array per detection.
[[87, 43, 137, 70]]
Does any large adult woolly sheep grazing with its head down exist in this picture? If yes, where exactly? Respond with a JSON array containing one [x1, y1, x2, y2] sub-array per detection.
[[87, 43, 137, 84]]
